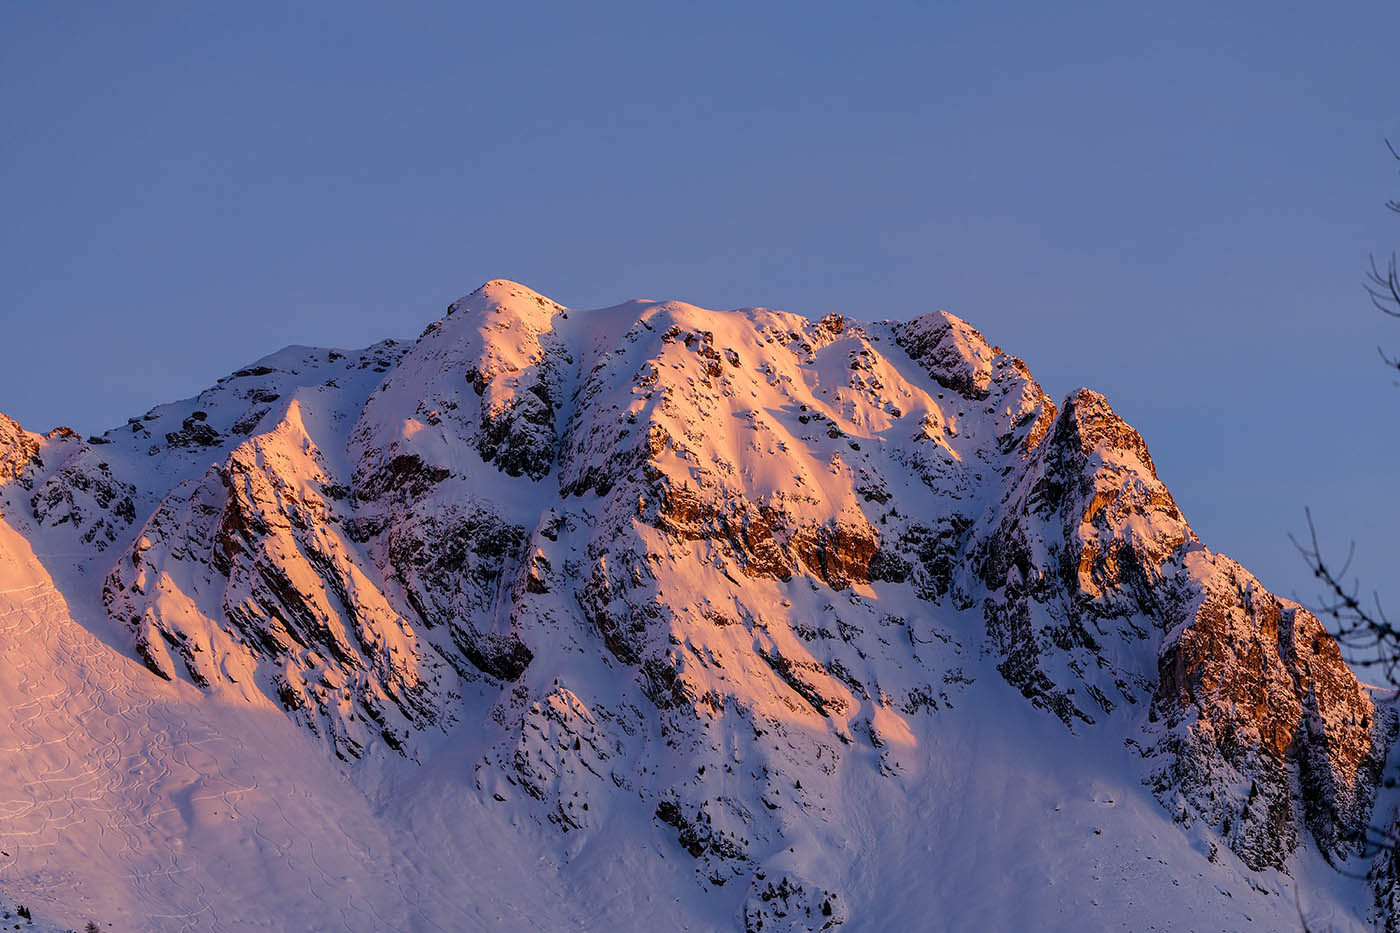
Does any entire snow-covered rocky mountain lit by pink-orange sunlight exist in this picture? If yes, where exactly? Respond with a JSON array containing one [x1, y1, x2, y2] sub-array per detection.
[[0, 282, 1400, 930]]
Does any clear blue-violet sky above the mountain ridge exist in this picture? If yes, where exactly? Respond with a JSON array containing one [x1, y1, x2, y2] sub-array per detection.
[[0, 0, 1400, 604]]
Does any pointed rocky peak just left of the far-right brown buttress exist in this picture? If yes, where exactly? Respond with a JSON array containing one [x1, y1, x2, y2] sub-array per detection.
[[970, 389, 1196, 724]]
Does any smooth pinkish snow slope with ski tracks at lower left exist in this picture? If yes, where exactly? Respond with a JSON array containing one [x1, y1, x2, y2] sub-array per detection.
[[0, 554, 547, 933]]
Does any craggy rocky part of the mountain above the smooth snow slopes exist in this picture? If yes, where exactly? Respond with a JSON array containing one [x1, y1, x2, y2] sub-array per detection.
[[0, 282, 1377, 930]]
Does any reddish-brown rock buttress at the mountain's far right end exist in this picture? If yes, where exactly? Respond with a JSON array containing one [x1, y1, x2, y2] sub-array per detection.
[[1156, 552, 1396, 869]]
